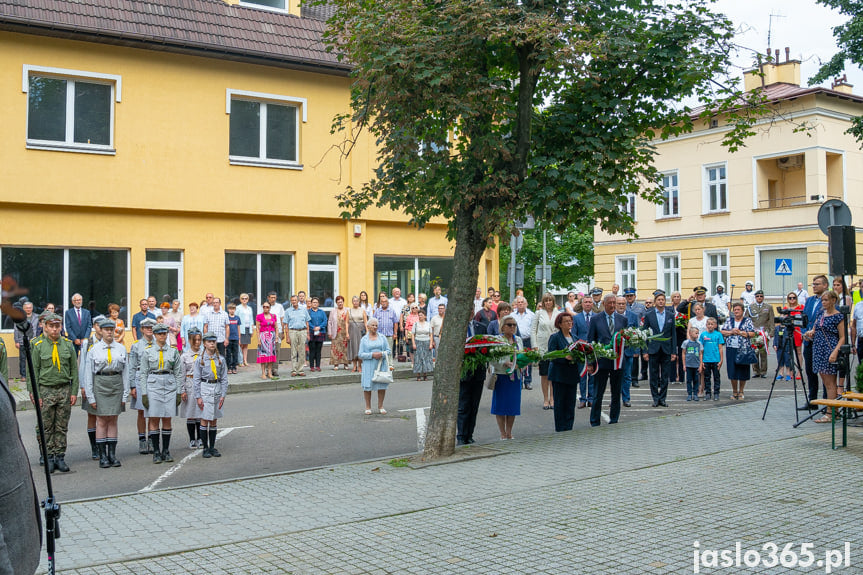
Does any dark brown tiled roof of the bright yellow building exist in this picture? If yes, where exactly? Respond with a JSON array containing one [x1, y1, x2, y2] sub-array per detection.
[[0, 0, 350, 75]]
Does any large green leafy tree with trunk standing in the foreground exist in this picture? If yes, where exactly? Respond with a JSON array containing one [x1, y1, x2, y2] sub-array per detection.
[[326, 0, 764, 458]]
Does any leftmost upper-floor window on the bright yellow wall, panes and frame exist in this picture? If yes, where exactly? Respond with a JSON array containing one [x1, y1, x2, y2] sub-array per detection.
[[22, 65, 120, 154]]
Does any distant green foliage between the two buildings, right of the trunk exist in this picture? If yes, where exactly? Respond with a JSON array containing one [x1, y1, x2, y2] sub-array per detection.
[[498, 225, 593, 309]]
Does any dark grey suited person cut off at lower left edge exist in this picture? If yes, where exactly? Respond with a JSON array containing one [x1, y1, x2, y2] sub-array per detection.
[[0, 374, 42, 575]]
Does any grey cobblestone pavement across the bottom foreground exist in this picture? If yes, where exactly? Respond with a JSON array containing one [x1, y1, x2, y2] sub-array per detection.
[[42, 397, 863, 575]]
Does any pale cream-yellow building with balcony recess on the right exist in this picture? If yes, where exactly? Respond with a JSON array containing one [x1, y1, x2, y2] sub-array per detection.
[[595, 55, 863, 301]]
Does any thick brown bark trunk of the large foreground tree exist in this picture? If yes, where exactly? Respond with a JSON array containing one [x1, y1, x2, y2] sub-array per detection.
[[423, 208, 488, 459]]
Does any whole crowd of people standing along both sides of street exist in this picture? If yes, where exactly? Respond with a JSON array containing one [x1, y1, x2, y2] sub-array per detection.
[[8, 275, 863, 472]]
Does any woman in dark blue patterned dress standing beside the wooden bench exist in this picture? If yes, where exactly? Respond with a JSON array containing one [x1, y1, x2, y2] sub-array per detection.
[[804, 290, 845, 423]]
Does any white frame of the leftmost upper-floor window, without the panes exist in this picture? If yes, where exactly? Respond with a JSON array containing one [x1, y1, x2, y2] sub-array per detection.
[[21, 64, 123, 156]]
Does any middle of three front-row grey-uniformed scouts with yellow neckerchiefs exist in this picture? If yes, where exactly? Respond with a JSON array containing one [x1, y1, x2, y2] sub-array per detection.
[[138, 323, 183, 463]]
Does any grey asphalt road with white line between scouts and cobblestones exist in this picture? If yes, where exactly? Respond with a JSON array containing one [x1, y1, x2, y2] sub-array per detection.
[[19, 368, 802, 502]]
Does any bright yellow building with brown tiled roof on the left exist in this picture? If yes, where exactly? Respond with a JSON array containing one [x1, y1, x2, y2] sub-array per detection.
[[0, 0, 498, 364]]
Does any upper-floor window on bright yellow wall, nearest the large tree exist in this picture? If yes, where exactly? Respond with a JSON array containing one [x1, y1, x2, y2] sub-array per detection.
[[227, 90, 306, 169]]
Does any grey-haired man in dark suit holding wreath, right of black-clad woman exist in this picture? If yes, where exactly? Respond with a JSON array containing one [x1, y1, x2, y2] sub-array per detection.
[[587, 294, 627, 427]]
